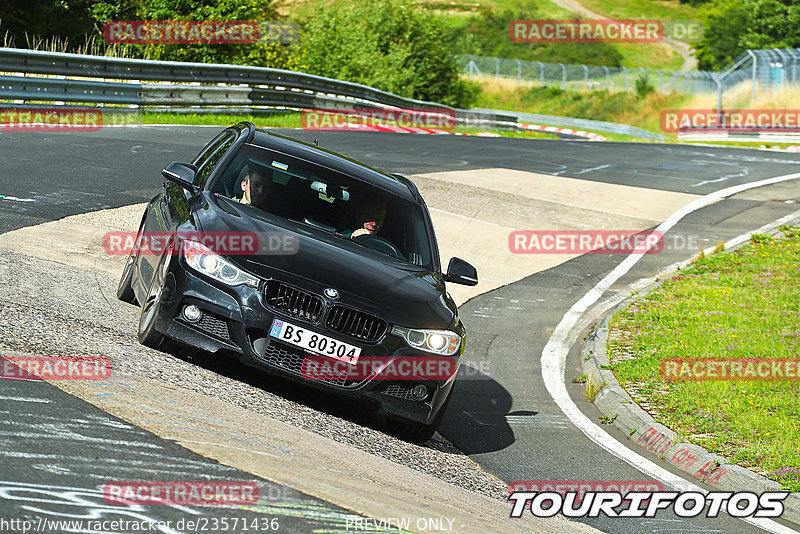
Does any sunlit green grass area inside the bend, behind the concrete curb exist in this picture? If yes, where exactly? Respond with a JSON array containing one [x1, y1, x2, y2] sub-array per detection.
[[608, 227, 800, 492]]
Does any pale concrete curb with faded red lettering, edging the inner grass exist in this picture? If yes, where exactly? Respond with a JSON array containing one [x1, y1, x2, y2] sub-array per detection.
[[580, 224, 800, 524]]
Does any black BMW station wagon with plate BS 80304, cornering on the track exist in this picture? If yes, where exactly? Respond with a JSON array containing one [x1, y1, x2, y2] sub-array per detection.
[[118, 122, 478, 441]]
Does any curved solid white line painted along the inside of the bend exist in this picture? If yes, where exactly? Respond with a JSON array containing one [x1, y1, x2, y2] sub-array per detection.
[[541, 173, 800, 534]]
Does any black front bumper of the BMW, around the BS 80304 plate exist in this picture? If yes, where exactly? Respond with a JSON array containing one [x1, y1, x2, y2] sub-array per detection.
[[148, 257, 460, 424]]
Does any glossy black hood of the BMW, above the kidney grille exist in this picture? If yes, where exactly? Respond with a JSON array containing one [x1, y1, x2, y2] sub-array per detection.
[[196, 198, 456, 328]]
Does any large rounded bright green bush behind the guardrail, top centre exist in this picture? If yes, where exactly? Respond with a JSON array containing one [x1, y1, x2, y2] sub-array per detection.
[[299, 0, 479, 107]]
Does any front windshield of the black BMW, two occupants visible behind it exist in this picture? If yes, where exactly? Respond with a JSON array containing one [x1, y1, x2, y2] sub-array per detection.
[[213, 145, 432, 270]]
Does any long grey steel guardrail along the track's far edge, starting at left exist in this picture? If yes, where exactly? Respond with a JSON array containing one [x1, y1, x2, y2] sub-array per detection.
[[0, 48, 663, 139]]
